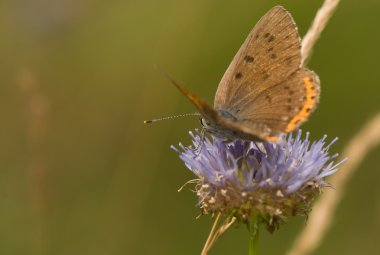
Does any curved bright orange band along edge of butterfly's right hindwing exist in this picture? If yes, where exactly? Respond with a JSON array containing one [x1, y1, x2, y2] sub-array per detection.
[[286, 77, 318, 132]]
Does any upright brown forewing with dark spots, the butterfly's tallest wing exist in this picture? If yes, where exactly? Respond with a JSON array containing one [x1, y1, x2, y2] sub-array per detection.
[[214, 6, 301, 114]]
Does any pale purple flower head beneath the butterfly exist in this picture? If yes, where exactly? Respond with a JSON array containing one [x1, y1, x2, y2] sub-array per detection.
[[172, 130, 343, 231]]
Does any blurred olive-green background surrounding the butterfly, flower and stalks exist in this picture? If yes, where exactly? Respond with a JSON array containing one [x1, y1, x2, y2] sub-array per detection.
[[0, 0, 380, 255]]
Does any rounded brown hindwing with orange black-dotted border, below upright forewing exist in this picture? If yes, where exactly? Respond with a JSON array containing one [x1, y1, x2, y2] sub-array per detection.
[[241, 68, 320, 135]]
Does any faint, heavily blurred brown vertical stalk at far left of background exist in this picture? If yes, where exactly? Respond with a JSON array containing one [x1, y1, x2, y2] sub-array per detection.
[[17, 69, 48, 254]]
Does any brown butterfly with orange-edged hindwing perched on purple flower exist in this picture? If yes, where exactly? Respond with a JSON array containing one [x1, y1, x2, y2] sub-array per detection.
[[166, 6, 320, 141]]
